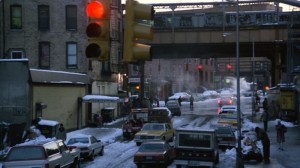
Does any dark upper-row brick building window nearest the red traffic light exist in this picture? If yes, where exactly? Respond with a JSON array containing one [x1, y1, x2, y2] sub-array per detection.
[[66, 5, 77, 30]]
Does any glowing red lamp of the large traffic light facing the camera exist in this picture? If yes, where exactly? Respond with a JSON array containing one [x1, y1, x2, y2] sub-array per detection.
[[86, 1, 105, 19]]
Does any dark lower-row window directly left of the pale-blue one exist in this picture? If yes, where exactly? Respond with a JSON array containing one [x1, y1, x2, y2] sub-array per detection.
[[39, 42, 50, 68]]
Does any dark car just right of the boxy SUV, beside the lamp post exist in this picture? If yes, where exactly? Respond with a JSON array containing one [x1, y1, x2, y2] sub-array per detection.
[[216, 126, 236, 150]]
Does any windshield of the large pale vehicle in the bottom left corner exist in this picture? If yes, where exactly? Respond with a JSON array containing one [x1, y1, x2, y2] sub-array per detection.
[[6, 147, 45, 161]]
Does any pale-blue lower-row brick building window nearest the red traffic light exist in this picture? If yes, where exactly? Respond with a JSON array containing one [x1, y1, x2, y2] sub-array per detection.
[[67, 42, 77, 68]]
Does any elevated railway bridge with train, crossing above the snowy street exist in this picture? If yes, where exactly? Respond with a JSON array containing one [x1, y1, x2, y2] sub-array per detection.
[[146, 0, 300, 84]]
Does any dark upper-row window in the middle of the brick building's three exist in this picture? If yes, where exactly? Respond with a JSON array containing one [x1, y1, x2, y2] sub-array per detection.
[[38, 5, 50, 30]]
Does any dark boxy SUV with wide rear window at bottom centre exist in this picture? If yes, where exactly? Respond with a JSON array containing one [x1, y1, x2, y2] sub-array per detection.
[[174, 128, 219, 168]]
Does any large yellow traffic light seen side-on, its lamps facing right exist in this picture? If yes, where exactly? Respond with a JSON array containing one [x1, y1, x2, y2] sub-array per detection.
[[123, 0, 155, 63]]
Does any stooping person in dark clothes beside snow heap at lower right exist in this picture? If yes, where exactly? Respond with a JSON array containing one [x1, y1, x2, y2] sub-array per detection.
[[255, 127, 270, 163]]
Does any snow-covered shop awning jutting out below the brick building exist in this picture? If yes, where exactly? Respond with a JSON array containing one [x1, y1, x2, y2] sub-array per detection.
[[82, 95, 120, 103]]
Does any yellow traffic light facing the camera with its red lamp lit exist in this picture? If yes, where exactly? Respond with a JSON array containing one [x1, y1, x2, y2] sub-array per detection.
[[85, 0, 110, 61]]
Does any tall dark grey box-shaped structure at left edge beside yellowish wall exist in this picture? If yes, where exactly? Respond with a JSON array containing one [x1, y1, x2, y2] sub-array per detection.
[[0, 59, 33, 149]]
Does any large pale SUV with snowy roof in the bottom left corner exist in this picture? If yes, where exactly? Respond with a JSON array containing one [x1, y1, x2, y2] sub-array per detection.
[[2, 140, 80, 168]]
